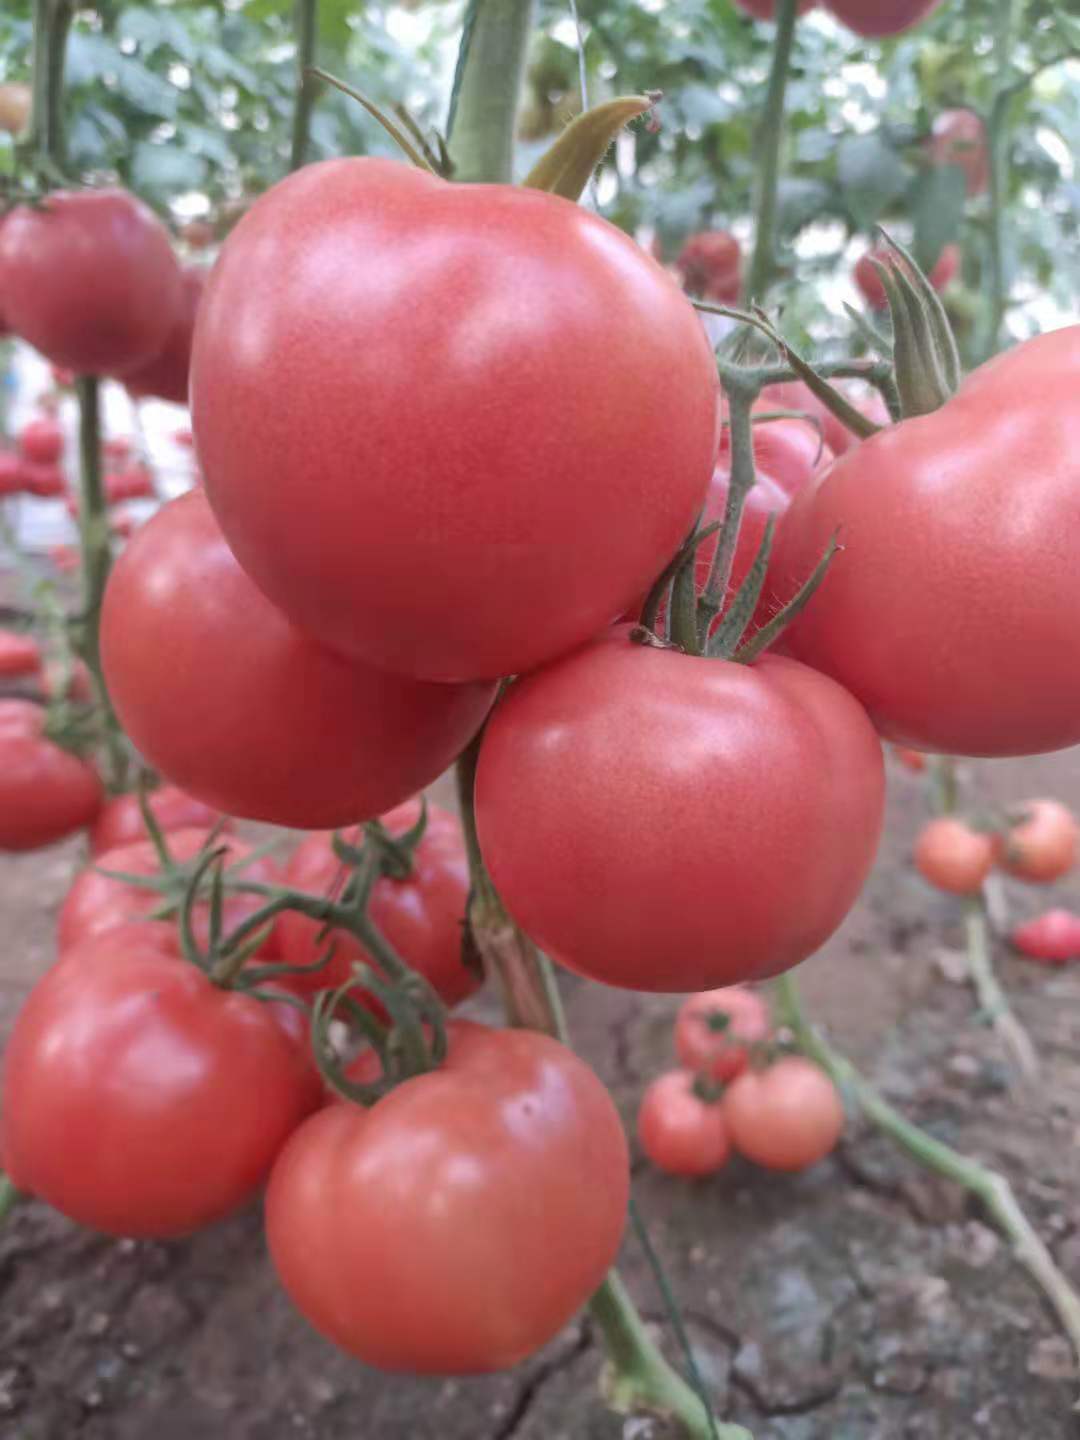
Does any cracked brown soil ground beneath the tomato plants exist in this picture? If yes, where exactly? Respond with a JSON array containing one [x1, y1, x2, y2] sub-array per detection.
[[0, 752, 1080, 1440]]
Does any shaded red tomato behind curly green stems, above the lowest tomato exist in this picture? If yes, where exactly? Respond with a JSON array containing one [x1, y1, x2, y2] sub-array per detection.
[[278, 801, 480, 1005]]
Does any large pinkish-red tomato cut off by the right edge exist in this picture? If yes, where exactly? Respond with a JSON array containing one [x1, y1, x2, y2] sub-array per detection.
[[770, 325, 1080, 755]]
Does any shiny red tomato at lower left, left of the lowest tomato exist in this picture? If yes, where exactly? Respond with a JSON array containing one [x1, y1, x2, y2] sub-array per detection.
[[3, 924, 321, 1237]]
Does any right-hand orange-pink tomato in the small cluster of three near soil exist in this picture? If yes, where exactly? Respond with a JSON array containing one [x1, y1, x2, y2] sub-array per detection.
[[723, 1056, 844, 1171]]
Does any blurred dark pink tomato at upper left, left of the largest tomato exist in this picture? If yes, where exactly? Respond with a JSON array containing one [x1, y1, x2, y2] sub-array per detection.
[[0, 190, 180, 374]]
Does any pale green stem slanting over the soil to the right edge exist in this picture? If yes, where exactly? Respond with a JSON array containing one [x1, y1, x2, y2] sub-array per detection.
[[778, 975, 1080, 1362]]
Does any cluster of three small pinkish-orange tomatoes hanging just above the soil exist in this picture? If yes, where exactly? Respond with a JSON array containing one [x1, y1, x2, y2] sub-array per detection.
[[638, 985, 844, 1176]]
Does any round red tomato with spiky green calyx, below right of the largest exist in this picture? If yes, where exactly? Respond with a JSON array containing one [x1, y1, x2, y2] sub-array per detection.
[[477, 626, 884, 992]]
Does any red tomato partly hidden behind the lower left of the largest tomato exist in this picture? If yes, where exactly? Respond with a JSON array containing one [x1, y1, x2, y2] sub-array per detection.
[[101, 491, 494, 828]]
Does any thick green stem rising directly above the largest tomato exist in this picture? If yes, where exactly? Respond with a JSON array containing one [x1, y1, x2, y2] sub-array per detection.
[[449, 0, 533, 184]]
